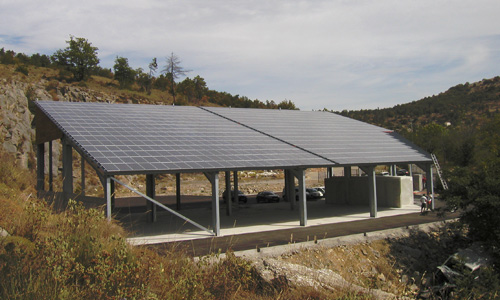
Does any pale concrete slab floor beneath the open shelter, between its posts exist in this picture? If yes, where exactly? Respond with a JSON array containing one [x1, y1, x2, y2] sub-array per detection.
[[121, 200, 420, 245]]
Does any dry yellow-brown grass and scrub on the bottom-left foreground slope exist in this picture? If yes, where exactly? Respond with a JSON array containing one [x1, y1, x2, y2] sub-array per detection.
[[0, 149, 372, 299]]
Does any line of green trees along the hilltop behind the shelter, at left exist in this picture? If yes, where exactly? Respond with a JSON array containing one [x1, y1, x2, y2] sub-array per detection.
[[0, 36, 297, 109]]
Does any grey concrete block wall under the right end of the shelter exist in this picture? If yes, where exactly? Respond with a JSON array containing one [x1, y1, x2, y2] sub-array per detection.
[[325, 176, 413, 207]]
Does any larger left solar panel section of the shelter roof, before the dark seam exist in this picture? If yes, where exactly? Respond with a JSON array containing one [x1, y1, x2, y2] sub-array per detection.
[[36, 101, 332, 175]]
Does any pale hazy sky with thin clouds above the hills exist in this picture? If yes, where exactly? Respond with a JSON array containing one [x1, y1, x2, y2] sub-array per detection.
[[0, 0, 500, 111]]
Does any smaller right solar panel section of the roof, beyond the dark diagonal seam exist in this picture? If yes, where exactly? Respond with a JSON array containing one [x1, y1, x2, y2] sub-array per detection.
[[204, 107, 431, 165]]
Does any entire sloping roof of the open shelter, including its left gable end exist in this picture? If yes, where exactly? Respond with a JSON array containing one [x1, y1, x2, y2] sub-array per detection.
[[35, 101, 432, 176]]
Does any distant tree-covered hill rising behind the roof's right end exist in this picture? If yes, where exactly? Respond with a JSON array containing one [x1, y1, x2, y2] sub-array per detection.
[[339, 76, 500, 131]]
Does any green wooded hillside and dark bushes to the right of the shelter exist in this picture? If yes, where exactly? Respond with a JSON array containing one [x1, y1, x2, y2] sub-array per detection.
[[342, 77, 500, 299]]
